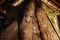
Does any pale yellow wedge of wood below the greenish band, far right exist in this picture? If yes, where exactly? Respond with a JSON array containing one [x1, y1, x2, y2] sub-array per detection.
[[48, 15, 60, 37]]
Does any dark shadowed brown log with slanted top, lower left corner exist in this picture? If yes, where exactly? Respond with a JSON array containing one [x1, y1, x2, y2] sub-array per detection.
[[0, 20, 18, 40]]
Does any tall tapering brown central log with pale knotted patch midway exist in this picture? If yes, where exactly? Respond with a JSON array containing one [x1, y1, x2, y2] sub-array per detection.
[[21, 2, 34, 40]]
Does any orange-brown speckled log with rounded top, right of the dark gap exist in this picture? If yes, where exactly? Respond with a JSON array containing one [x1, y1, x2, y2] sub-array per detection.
[[36, 8, 60, 40]]
